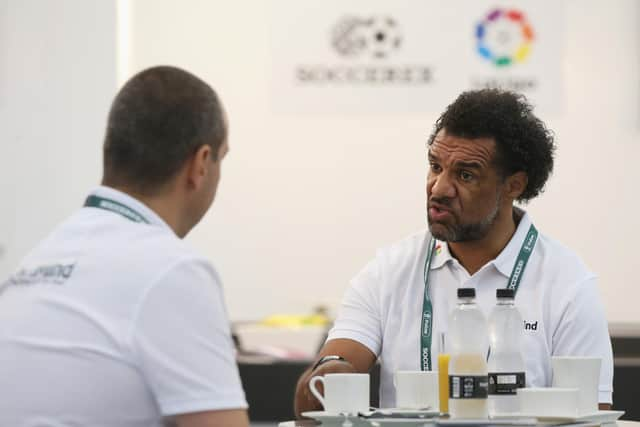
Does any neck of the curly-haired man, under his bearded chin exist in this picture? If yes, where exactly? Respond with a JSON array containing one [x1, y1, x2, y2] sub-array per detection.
[[448, 207, 519, 276]]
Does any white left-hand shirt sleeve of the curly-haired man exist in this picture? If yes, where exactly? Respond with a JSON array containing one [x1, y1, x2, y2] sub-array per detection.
[[327, 254, 382, 355]]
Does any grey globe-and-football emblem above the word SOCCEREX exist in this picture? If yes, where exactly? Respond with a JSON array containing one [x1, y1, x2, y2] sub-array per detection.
[[331, 16, 402, 58]]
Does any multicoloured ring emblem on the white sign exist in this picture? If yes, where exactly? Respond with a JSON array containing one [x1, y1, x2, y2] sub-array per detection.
[[476, 9, 533, 67]]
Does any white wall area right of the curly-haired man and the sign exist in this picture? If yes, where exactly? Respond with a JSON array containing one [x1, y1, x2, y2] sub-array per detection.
[[533, 0, 640, 322]]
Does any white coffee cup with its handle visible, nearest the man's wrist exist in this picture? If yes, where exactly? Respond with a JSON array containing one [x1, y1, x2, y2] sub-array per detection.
[[309, 374, 369, 414]]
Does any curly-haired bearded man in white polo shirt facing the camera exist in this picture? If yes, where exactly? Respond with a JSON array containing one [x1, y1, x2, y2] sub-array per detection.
[[295, 89, 613, 415]]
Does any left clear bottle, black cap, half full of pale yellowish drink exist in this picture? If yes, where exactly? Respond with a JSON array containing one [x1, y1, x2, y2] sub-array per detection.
[[447, 288, 488, 418]]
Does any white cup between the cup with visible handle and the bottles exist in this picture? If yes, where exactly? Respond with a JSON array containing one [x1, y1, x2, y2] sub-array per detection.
[[393, 371, 440, 409]]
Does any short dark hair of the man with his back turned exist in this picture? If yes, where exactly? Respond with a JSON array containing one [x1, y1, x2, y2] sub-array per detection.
[[102, 66, 227, 194]]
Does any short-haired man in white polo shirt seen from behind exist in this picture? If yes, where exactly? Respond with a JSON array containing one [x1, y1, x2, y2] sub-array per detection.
[[0, 66, 248, 427]]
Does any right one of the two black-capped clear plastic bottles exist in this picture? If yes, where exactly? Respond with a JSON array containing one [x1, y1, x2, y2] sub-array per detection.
[[488, 289, 525, 415]]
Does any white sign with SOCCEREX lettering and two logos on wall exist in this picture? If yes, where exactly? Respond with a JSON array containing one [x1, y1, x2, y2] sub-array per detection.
[[271, 0, 563, 113]]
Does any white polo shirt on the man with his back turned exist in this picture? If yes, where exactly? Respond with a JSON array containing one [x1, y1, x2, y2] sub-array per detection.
[[0, 187, 247, 426]]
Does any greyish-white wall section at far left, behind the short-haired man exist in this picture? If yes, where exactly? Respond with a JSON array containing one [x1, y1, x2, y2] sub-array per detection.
[[0, 0, 116, 276]]
